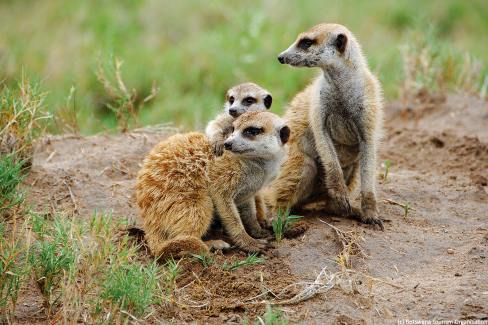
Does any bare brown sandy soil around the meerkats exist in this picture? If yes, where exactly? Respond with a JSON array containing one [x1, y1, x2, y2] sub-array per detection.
[[17, 95, 488, 324]]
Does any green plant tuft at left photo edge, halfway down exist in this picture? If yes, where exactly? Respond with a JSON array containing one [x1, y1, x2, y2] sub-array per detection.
[[0, 153, 24, 217]]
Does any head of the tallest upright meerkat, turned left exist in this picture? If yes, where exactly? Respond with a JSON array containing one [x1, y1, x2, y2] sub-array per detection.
[[278, 23, 362, 68]]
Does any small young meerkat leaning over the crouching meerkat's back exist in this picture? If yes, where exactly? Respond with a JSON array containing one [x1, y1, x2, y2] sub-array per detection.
[[205, 82, 273, 156]]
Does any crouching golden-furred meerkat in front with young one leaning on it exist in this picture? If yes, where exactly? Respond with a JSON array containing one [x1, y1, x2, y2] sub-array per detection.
[[136, 111, 290, 259]]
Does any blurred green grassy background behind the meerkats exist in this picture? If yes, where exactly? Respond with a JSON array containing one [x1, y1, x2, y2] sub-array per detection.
[[0, 0, 488, 134]]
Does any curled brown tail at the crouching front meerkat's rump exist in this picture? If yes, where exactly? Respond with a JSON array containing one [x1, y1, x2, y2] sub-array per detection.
[[149, 235, 209, 260]]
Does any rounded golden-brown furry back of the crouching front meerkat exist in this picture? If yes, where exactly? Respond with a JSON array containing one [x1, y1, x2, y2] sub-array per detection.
[[136, 133, 213, 251]]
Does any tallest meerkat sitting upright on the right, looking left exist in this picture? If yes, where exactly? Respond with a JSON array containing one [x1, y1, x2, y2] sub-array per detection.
[[271, 23, 383, 229]]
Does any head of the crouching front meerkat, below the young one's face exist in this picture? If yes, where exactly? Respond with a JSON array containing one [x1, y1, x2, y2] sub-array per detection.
[[224, 111, 290, 159]]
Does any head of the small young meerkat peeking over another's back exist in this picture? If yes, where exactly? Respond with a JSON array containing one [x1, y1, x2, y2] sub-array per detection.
[[224, 82, 273, 118]]
